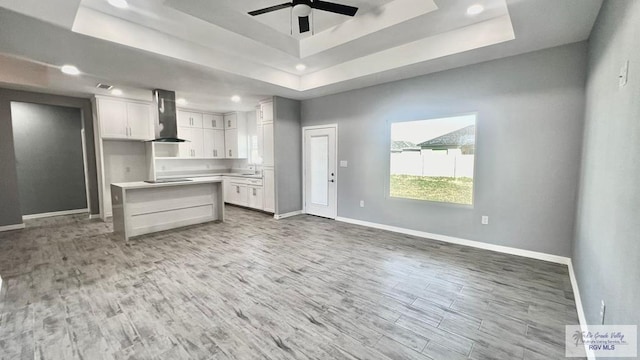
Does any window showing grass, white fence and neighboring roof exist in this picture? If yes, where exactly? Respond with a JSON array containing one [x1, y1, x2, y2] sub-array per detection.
[[389, 114, 476, 205]]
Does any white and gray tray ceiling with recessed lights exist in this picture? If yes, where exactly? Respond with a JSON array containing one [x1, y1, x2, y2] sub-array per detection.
[[0, 0, 602, 111]]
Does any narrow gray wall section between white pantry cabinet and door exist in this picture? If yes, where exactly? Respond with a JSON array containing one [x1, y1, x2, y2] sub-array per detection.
[[273, 96, 302, 214]]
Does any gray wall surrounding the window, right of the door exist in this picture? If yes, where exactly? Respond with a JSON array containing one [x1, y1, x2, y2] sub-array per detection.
[[302, 42, 587, 256]]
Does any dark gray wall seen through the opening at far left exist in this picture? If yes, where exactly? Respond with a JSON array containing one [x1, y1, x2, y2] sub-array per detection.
[[11, 102, 87, 215]]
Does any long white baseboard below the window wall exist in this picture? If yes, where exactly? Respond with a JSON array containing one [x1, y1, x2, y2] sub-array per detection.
[[336, 217, 571, 265]]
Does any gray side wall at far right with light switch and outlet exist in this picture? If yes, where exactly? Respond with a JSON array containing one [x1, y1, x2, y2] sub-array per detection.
[[573, 0, 640, 325]]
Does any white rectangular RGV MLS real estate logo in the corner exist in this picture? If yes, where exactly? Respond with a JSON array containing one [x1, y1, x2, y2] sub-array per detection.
[[565, 325, 638, 358]]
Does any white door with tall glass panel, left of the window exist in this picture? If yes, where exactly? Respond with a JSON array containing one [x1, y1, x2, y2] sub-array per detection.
[[304, 125, 338, 219]]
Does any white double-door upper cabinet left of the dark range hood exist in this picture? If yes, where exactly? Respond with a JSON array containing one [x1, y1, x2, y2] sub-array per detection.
[[96, 98, 153, 140]]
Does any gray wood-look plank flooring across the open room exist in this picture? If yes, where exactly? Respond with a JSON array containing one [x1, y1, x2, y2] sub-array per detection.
[[0, 206, 578, 360]]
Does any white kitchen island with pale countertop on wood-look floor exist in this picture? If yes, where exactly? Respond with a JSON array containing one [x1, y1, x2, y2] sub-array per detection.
[[111, 177, 224, 240]]
